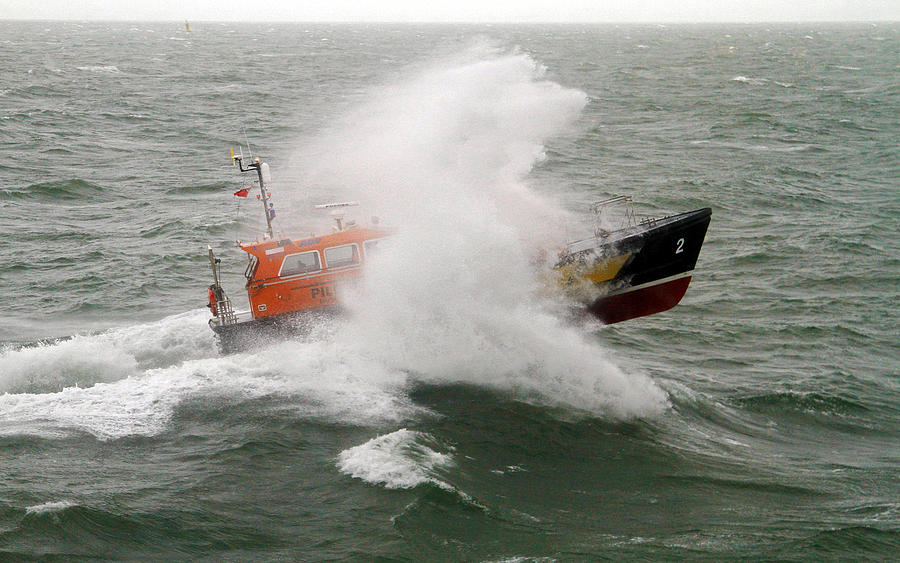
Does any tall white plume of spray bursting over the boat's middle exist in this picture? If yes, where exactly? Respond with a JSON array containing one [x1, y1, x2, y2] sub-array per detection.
[[288, 45, 667, 418]]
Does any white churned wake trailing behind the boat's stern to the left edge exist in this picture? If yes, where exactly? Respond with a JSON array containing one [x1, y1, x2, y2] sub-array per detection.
[[0, 311, 425, 440]]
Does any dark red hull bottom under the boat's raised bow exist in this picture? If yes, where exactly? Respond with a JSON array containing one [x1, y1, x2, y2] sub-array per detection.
[[588, 275, 691, 324]]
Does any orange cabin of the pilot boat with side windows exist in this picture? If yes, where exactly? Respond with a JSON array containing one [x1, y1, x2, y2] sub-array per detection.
[[240, 228, 390, 319]]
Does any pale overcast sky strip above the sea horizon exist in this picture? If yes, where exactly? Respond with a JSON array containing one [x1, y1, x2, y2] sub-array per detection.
[[0, 0, 900, 22]]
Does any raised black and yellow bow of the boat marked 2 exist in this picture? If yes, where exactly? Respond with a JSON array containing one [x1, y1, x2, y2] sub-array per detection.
[[553, 196, 712, 324]]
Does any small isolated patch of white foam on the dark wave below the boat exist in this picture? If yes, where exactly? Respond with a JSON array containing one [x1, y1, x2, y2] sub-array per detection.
[[337, 428, 453, 489]]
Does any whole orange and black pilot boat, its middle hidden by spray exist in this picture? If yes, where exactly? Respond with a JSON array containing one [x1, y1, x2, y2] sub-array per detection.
[[207, 153, 711, 352]]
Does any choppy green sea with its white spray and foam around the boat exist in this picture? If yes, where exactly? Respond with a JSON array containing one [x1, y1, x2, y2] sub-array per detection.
[[0, 21, 900, 561]]
